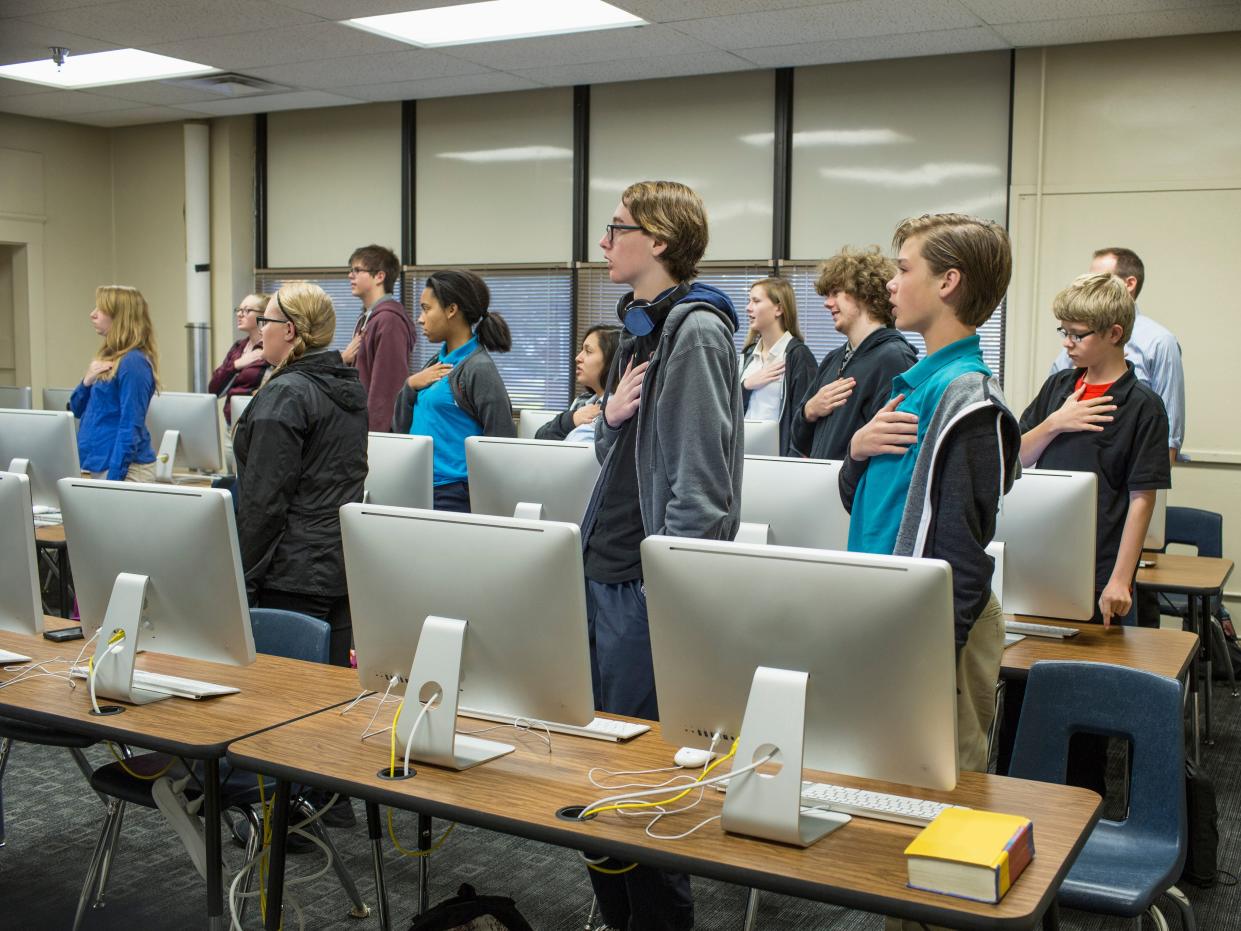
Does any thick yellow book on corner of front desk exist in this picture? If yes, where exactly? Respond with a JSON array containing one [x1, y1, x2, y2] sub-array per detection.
[[905, 808, 1034, 904]]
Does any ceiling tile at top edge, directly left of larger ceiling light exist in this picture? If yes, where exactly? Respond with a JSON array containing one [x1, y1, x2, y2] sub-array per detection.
[[26, 0, 316, 48]]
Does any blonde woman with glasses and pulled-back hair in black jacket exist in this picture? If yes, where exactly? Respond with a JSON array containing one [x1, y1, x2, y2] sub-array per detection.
[[233, 282, 367, 665]]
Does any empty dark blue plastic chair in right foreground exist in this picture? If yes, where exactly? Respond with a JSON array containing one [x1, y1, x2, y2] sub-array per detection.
[[1009, 662, 1195, 931]]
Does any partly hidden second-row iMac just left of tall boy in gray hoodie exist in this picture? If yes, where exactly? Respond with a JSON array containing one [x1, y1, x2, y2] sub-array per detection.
[[465, 437, 599, 524]]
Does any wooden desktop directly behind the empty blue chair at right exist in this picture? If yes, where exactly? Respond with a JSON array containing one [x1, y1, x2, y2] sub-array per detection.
[[1000, 617, 1198, 679]]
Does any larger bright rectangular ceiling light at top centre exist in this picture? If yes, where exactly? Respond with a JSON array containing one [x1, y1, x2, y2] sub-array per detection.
[[345, 0, 647, 48]]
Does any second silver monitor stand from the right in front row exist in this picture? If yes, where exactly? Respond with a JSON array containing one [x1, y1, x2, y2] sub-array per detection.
[[396, 614, 514, 770]]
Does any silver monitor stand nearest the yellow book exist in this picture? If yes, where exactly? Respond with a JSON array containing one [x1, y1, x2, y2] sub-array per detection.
[[720, 665, 851, 847]]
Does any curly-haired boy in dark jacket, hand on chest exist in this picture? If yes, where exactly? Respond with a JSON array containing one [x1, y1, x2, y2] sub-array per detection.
[[793, 246, 917, 459]]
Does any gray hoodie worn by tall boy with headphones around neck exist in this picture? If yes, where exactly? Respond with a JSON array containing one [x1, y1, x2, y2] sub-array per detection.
[[582, 299, 743, 546]]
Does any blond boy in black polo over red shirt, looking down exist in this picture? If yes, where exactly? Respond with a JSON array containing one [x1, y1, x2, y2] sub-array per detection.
[[1021, 274, 1172, 627]]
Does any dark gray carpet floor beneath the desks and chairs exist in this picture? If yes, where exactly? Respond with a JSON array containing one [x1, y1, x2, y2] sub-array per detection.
[[0, 686, 1241, 931]]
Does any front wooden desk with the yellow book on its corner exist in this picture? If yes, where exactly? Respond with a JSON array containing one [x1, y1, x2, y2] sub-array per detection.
[[228, 708, 1101, 929]]
